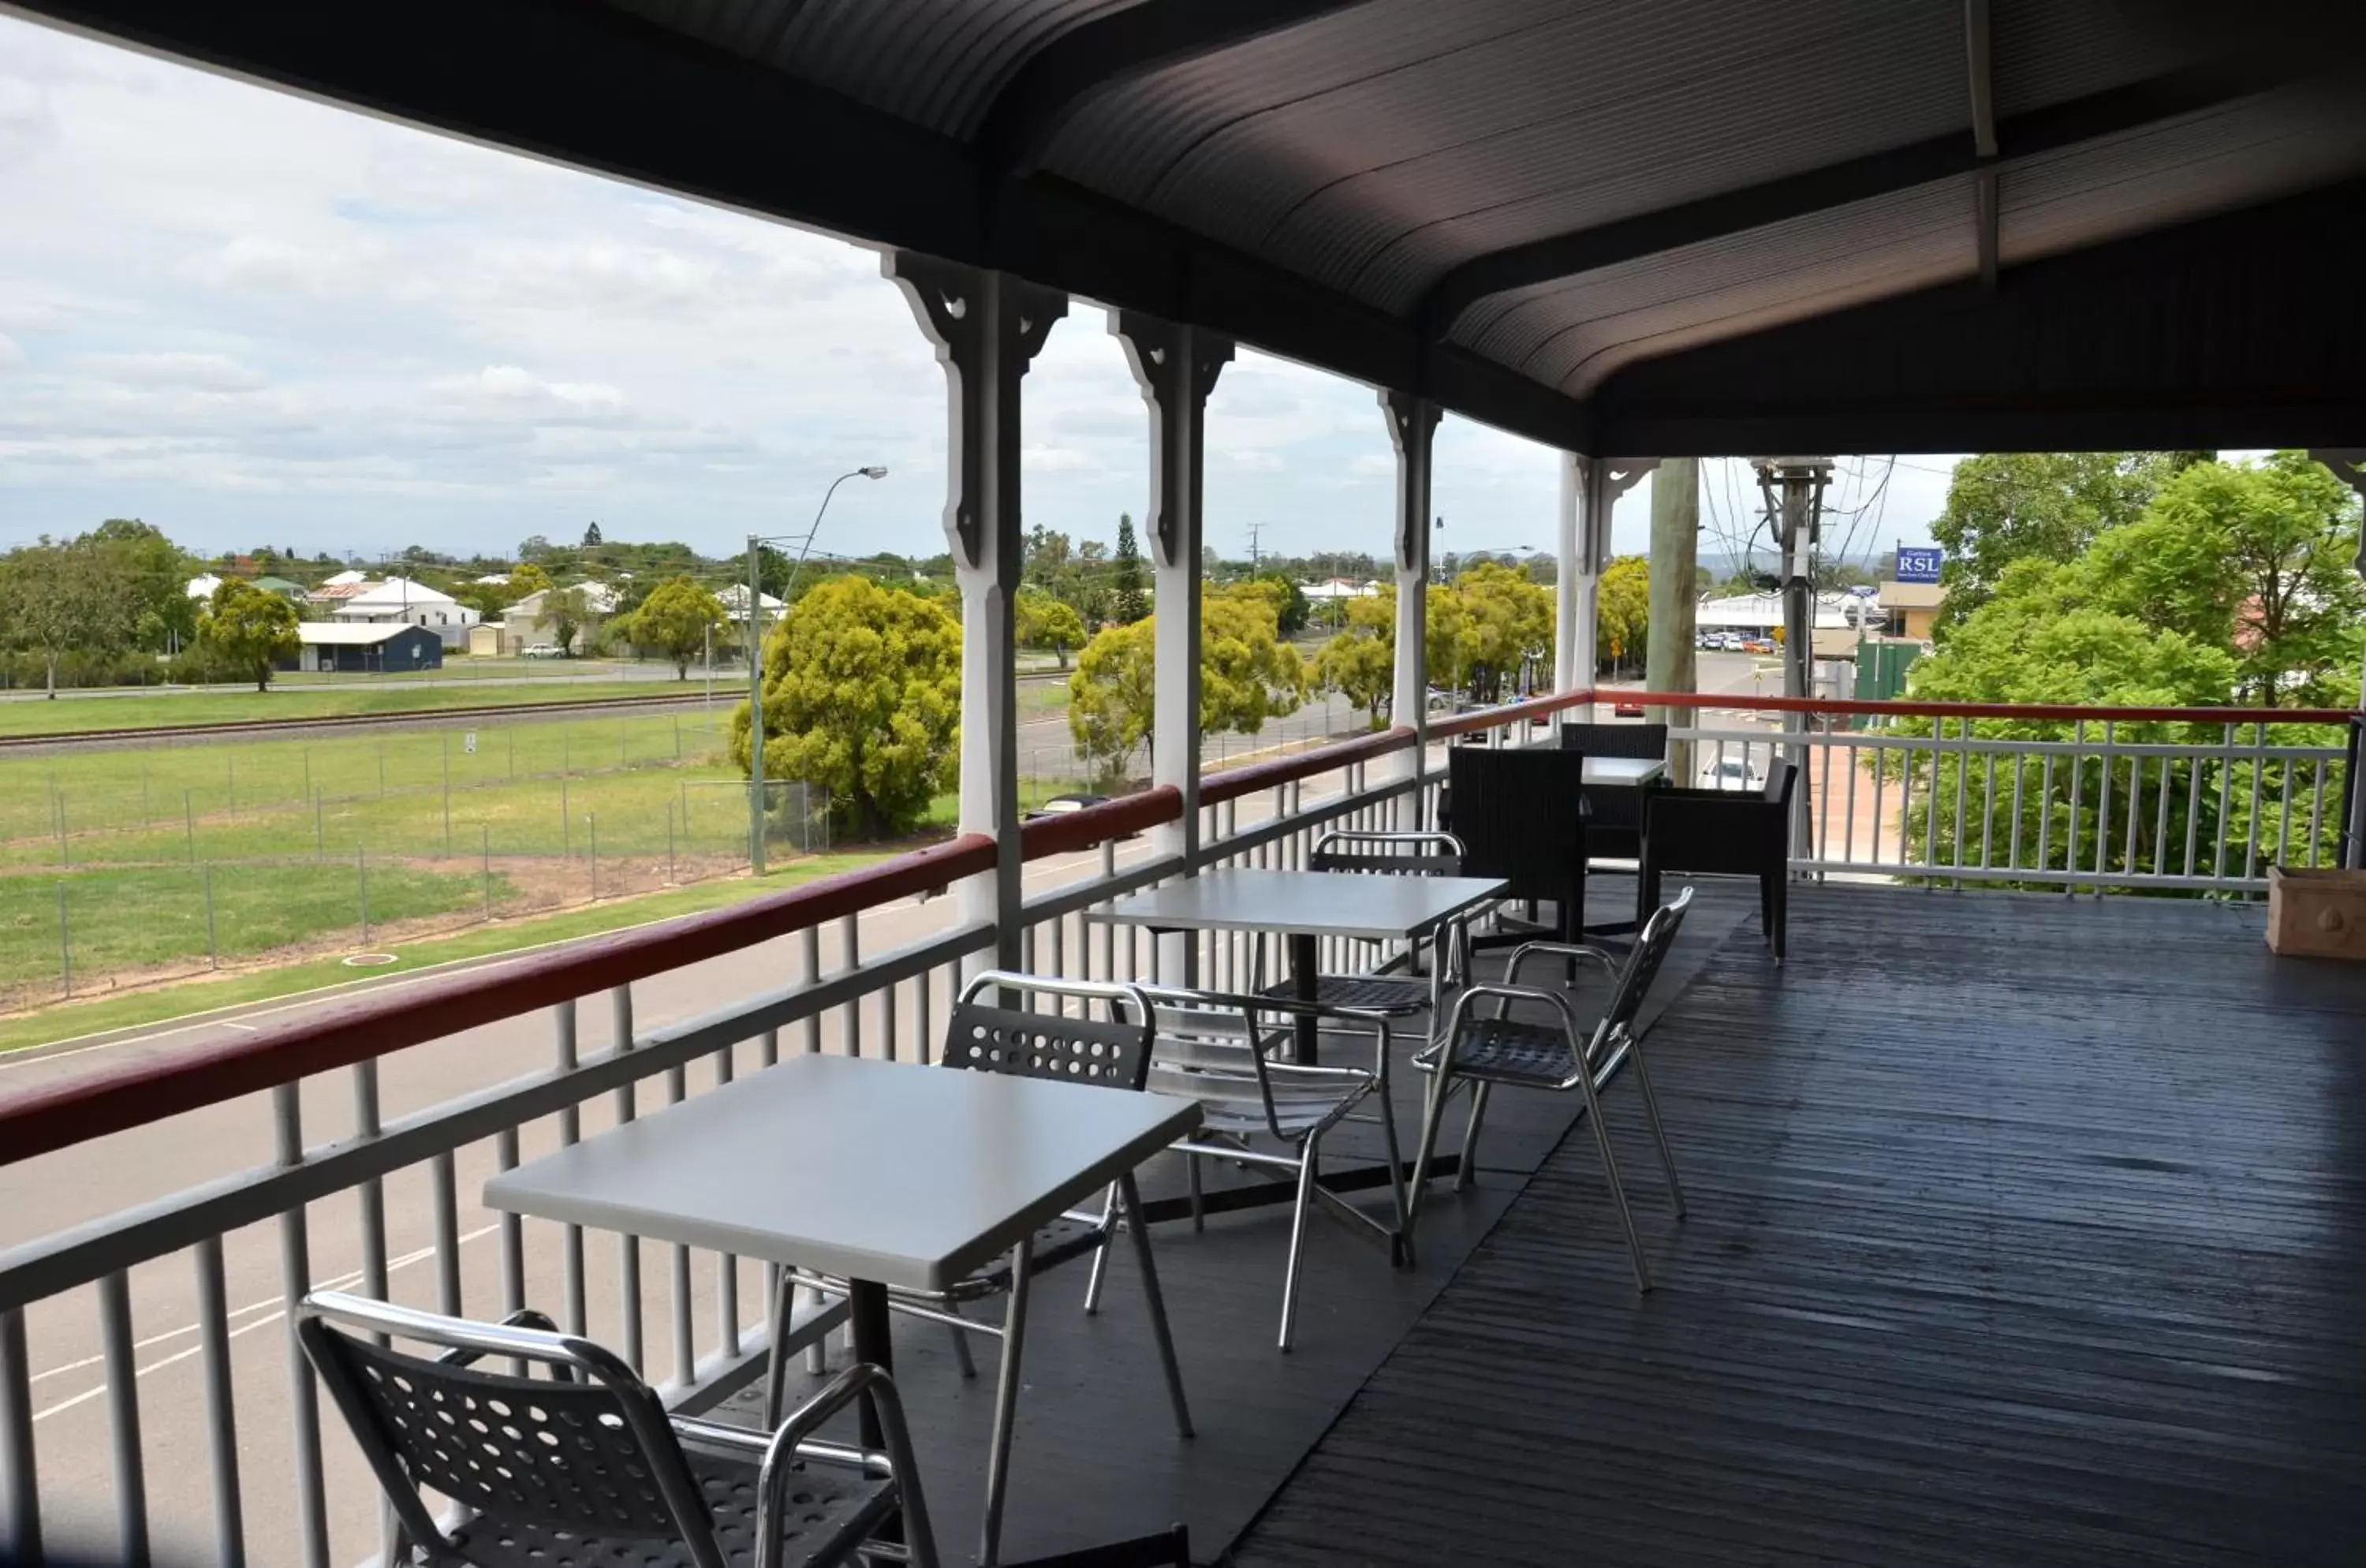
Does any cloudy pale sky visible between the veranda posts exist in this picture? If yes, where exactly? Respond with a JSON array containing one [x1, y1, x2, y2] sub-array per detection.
[[0, 17, 1952, 569]]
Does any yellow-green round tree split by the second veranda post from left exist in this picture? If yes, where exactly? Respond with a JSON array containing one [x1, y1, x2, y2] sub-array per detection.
[[1067, 589, 1306, 778]]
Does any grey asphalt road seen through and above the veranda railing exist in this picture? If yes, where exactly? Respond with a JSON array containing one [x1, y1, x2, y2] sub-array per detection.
[[0, 766, 1372, 1566]]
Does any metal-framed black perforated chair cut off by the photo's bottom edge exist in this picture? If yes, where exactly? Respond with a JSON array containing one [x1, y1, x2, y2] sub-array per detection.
[[296, 1291, 937, 1568]]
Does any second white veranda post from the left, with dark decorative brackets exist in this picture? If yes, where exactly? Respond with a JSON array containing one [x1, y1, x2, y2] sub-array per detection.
[[1110, 310, 1233, 984]]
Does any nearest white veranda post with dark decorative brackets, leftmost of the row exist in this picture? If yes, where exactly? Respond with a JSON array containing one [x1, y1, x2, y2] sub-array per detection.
[[883, 251, 1067, 969]]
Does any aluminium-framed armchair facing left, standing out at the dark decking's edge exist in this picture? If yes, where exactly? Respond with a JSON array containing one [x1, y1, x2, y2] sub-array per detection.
[[1410, 887, 1692, 1289]]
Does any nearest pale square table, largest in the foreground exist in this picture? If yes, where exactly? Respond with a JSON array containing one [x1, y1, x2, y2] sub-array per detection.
[[485, 1055, 1200, 1561]]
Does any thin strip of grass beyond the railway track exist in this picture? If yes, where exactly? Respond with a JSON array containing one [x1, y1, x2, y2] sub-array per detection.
[[0, 677, 715, 736]]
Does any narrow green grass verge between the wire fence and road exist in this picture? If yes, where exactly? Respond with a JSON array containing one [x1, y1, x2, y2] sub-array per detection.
[[0, 851, 894, 1052]]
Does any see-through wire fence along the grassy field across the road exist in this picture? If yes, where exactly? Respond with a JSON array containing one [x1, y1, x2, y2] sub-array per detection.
[[0, 707, 830, 1010]]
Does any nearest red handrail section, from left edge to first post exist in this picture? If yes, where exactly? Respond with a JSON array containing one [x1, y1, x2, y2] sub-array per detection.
[[0, 832, 994, 1166]]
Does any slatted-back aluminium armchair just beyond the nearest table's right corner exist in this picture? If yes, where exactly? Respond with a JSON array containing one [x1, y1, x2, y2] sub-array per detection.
[[1131, 986, 1410, 1350]]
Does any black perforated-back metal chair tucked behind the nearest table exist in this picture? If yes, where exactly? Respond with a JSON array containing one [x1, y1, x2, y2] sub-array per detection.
[[764, 969, 1192, 1568]]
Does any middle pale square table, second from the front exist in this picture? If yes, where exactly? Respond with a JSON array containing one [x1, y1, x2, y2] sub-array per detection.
[[1086, 868, 1505, 1062]]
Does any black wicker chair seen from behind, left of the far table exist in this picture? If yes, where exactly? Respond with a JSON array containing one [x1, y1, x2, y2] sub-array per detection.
[[1446, 745, 1588, 946]]
